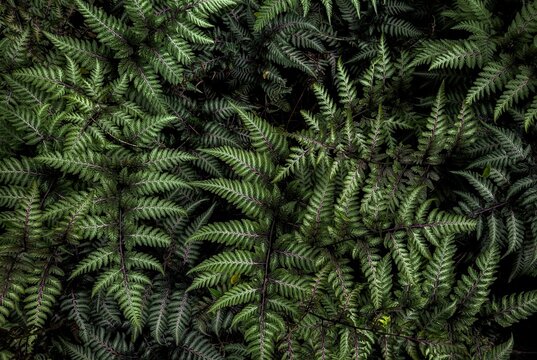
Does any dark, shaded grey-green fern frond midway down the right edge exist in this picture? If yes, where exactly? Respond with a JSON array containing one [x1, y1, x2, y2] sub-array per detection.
[[456, 125, 537, 279]]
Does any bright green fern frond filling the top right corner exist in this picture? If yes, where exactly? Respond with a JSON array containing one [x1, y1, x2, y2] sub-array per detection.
[[416, 1, 537, 131]]
